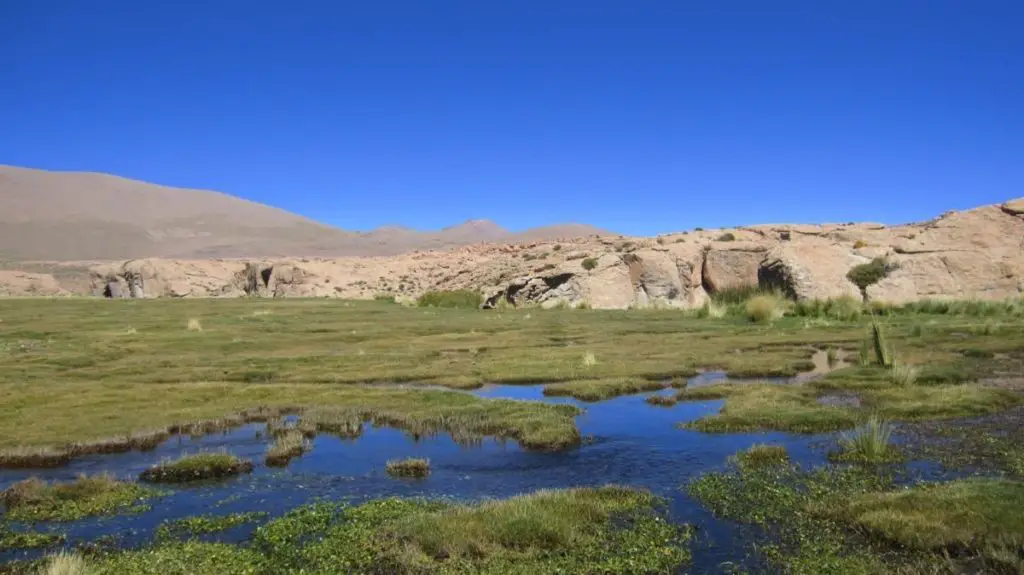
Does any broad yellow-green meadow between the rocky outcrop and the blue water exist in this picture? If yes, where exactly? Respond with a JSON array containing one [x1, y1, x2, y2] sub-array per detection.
[[0, 294, 1024, 452]]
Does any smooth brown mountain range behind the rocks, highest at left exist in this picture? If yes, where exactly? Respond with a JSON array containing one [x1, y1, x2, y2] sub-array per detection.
[[0, 166, 605, 261]]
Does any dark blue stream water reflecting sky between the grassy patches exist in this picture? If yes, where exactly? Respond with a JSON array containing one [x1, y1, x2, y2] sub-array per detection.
[[0, 386, 958, 572]]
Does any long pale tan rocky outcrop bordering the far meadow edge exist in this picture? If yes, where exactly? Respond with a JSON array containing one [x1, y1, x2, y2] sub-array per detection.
[[6, 200, 1024, 309]]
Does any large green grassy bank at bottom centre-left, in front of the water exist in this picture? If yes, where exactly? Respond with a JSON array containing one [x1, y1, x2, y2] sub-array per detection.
[[75, 487, 690, 575]]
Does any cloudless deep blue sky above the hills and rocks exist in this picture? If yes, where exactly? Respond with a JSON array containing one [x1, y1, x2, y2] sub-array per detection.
[[0, 0, 1024, 233]]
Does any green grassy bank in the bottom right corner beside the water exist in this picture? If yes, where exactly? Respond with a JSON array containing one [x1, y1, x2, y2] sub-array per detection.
[[687, 453, 1024, 575]]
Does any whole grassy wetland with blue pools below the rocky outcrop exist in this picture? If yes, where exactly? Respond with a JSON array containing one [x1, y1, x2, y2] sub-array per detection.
[[0, 291, 1024, 573]]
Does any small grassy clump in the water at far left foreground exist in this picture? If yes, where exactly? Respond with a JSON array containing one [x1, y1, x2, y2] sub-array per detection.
[[0, 475, 158, 522]]
